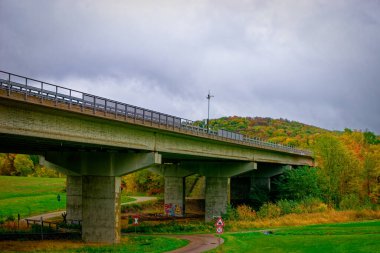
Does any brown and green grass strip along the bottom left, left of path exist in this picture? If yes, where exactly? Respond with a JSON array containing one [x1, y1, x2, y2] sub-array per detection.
[[0, 236, 188, 253]]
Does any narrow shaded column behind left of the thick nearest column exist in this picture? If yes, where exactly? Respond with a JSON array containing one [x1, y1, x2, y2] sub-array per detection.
[[66, 176, 82, 220]]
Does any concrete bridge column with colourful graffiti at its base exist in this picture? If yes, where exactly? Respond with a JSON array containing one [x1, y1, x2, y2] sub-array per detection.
[[165, 176, 185, 216]]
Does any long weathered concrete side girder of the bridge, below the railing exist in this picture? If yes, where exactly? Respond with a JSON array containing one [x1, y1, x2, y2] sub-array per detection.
[[0, 99, 313, 167]]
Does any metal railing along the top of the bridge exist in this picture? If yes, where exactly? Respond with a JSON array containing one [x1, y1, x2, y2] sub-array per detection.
[[0, 70, 311, 156]]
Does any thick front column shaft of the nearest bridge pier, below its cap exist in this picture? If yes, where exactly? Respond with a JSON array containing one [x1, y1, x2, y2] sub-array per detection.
[[82, 176, 121, 243]]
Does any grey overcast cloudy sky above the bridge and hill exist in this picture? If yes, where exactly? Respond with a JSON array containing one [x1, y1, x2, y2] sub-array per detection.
[[0, 0, 380, 134]]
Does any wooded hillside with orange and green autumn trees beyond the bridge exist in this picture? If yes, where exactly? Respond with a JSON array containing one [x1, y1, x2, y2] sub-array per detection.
[[197, 116, 380, 206]]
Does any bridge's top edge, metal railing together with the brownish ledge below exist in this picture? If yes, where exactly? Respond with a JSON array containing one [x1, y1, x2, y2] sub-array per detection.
[[0, 71, 312, 157]]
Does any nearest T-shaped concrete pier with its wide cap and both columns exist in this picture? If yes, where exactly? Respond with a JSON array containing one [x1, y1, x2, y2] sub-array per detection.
[[42, 152, 161, 243]]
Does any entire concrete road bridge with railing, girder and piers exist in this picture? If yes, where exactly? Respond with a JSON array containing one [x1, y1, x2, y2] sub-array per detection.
[[0, 71, 313, 242]]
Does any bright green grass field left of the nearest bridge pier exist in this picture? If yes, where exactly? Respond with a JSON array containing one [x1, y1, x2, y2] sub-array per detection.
[[0, 176, 66, 219]]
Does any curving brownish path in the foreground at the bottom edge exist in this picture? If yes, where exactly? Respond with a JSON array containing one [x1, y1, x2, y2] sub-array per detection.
[[164, 234, 224, 253]]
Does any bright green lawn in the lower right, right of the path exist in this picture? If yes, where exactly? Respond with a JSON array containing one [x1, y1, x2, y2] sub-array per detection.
[[210, 221, 380, 253]]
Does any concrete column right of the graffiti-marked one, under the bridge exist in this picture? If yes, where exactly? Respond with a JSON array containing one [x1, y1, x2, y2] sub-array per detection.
[[205, 177, 230, 221]]
